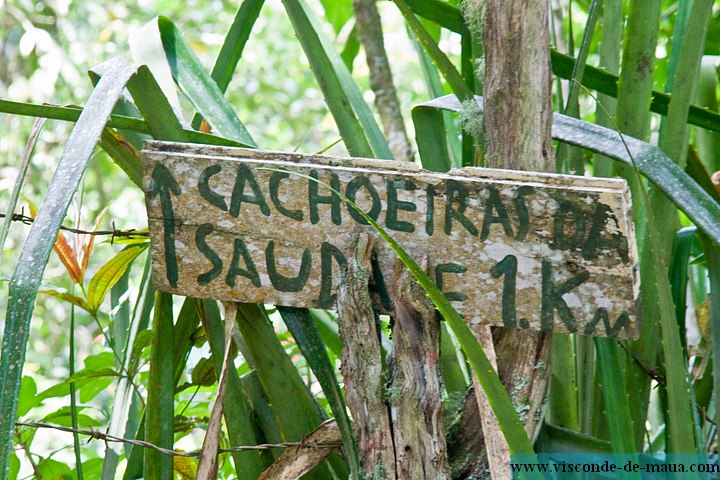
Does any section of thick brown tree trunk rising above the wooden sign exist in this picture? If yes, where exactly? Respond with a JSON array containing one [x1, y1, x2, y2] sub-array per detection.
[[483, 0, 553, 172]]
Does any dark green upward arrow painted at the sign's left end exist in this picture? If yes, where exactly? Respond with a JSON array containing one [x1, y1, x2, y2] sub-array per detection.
[[148, 163, 182, 287]]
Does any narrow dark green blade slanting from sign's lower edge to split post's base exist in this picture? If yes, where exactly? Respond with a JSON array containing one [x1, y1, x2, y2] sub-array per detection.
[[278, 307, 362, 480]]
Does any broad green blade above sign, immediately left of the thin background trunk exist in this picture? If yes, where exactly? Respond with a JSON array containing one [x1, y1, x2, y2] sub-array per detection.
[[283, 0, 392, 159]]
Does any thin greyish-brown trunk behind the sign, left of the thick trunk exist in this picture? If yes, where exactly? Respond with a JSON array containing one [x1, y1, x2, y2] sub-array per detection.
[[353, 0, 413, 162]]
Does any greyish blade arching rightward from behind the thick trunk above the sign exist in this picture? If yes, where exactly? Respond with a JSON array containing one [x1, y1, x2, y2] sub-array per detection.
[[414, 95, 720, 248]]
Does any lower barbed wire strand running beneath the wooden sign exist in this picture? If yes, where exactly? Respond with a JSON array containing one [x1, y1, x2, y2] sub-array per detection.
[[15, 422, 342, 457]]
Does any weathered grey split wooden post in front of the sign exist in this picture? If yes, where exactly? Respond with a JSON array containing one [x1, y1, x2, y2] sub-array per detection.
[[338, 236, 450, 480]]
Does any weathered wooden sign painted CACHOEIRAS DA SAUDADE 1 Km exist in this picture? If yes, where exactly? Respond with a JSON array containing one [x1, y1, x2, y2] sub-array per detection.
[[143, 142, 638, 338]]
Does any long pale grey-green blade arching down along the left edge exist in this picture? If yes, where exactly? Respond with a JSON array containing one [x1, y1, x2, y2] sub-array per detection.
[[0, 59, 136, 478]]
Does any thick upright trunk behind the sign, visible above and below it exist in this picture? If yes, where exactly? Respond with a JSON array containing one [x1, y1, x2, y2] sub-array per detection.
[[481, 0, 554, 478]]
